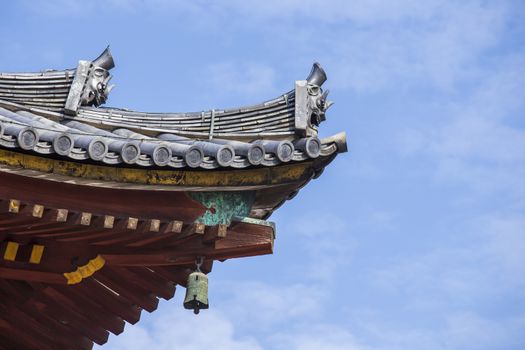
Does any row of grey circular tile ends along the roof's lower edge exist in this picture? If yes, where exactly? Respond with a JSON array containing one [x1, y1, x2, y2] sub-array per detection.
[[0, 107, 322, 169]]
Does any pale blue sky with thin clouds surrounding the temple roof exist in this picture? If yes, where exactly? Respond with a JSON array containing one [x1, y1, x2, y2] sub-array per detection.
[[0, 0, 525, 350]]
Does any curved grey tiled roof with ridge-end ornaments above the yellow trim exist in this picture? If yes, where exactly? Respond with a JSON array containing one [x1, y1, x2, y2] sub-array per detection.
[[0, 49, 345, 169]]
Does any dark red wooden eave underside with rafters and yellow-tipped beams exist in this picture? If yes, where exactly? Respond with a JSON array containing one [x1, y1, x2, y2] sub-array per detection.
[[0, 190, 275, 349]]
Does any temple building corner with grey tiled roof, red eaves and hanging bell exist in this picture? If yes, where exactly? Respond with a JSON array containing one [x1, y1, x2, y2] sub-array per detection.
[[0, 49, 346, 350]]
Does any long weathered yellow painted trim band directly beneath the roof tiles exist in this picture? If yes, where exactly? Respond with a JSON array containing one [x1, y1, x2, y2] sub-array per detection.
[[0, 149, 313, 187]]
